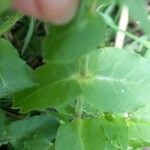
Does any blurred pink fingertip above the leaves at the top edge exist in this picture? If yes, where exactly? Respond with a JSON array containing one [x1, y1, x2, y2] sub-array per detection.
[[13, 0, 79, 25]]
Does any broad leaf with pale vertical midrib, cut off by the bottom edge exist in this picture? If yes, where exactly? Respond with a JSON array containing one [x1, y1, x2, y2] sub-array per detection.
[[56, 119, 128, 150]]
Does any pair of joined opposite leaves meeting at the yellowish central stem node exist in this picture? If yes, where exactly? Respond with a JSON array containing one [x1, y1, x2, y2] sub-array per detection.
[[14, 48, 150, 113]]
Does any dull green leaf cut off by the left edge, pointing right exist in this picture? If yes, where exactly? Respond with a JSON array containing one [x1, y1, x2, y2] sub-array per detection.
[[0, 39, 34, 98]]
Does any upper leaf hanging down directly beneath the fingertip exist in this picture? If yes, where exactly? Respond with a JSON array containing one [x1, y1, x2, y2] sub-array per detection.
[[43, 0, 108, 62]]
